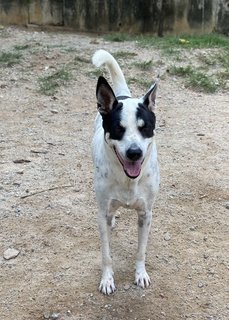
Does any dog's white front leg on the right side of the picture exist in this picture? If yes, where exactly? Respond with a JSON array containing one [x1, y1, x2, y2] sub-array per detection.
[[135, 210, 152, 288]]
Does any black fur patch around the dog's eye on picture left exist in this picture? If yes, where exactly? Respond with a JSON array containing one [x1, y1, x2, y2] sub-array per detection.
[[102, 102, 125, 140]]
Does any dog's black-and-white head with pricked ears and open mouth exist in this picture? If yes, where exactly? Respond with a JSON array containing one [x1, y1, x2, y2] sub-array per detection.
[[96, 77, 157, 179]]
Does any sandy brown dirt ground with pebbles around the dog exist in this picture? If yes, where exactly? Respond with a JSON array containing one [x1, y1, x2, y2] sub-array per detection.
[[0, 28, 229, 320]]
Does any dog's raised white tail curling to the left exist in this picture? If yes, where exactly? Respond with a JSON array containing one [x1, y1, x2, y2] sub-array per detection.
[[92, 49, 131, 97]]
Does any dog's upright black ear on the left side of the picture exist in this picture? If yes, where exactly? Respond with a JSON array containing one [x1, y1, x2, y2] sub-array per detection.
[[96, 76, 118, 114]]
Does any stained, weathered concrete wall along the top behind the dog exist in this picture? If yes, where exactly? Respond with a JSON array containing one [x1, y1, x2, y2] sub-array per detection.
[[0, 0, 229, 35]]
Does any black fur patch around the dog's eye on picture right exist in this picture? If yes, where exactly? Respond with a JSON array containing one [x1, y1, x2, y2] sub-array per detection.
[[136, 103, 156, 138]]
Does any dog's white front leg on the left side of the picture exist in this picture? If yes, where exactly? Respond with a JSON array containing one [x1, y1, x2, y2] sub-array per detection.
[[98, 210, 116, 295]]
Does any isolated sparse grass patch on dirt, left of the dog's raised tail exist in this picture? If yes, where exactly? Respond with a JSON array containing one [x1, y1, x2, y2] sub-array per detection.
[[38, 67, 72, 95]]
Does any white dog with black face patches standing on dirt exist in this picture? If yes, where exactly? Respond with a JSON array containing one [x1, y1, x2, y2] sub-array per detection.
[[92, 49, 160, 295]]
